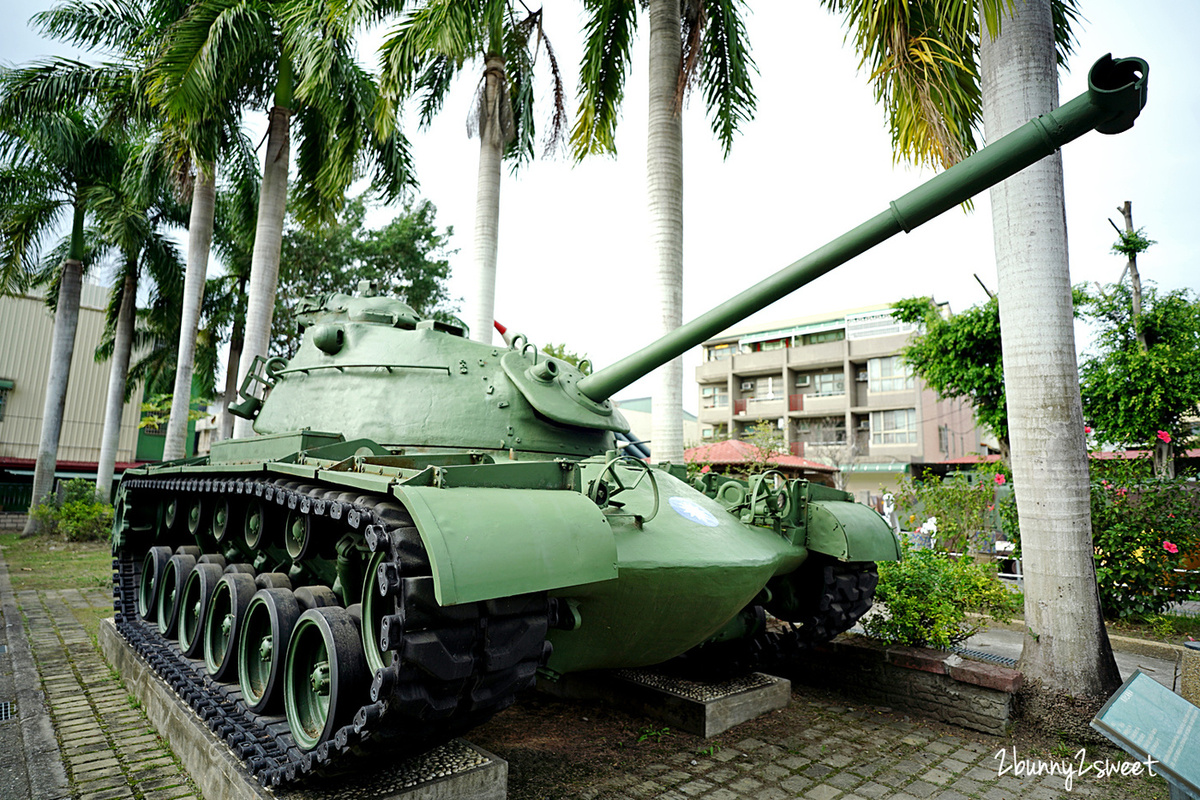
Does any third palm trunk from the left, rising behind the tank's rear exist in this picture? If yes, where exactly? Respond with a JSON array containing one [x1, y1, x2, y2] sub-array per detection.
[[162, 164, 217, 461]]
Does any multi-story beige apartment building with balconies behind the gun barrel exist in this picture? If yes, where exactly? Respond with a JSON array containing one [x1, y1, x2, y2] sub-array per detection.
[[696, 305, 986, 500]]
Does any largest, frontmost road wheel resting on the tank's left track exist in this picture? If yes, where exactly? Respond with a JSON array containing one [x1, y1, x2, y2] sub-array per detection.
[[283, 607, 370, 751]]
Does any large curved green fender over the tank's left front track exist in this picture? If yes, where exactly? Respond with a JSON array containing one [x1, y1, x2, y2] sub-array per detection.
[[394, 486, 617, 606]]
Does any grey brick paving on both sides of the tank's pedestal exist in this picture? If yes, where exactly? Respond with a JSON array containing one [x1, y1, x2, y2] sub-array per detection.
[[0, 551, 1166, 800]]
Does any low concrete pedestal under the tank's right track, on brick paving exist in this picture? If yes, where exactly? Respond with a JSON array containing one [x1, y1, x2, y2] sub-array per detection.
[[538, 669, 792, 739]]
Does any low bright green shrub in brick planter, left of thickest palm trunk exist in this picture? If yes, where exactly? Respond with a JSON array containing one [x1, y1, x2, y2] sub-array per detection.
[[863, 546, 1021, 650]]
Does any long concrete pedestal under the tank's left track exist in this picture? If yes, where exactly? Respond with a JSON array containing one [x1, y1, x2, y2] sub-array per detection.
[[100, 619, 509, 800]]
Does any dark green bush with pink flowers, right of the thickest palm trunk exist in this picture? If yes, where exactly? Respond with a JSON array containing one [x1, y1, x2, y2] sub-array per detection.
[[1092, 459, 1200, 619]]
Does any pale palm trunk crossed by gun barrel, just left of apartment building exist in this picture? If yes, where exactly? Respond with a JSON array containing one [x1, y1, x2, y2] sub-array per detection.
[[646, 0, 683, 464]]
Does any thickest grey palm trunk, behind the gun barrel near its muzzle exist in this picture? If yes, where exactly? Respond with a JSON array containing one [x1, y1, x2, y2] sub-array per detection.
[[980, 0, 1121, 697]]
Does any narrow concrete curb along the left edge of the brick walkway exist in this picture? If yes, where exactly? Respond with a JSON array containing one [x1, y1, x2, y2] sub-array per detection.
[[0, 546, 71, 799]]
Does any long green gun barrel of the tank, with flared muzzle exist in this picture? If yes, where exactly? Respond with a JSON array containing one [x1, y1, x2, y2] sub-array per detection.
[[578, 55, 1150, 401]]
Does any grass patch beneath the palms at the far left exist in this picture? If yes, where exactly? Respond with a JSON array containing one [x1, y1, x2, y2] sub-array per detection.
[[0, 533, 113, 591]]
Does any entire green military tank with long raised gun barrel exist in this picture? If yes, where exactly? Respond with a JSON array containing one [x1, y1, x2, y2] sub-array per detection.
[[113, 56, 1148, 784]]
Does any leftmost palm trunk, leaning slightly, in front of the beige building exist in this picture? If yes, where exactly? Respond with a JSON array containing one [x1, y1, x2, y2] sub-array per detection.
[[22, 204, 84, 536]]
